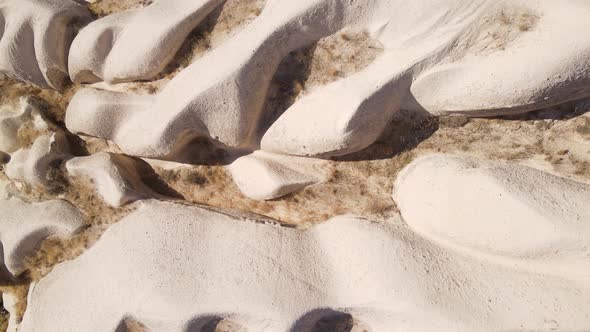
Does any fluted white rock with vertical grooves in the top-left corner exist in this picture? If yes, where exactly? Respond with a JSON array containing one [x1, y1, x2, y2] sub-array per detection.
[[0, 0, 91, 89]]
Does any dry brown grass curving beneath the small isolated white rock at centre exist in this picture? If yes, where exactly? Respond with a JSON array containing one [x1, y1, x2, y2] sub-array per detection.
[[155, 144, 414, 226]]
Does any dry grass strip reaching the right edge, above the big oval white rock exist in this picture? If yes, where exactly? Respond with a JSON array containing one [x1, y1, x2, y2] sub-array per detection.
[[414, 105, 590, 182]]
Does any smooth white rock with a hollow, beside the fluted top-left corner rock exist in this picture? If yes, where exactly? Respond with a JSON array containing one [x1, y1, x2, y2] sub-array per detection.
[[69, 0, 223, 83]]
